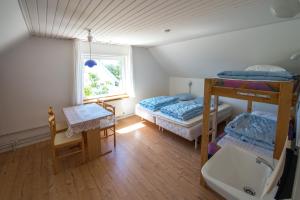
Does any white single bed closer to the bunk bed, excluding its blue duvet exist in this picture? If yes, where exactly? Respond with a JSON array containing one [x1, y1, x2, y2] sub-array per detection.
[[154, 103, 232, 148]]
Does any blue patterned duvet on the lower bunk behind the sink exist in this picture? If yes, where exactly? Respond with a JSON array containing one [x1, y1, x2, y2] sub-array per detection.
[[225, 113, 276, 150]]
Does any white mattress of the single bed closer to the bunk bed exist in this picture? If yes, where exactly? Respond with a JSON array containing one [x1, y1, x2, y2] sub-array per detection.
[[155, 104, 232, 127]]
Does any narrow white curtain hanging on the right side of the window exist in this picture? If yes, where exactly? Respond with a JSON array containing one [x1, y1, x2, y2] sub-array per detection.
[[126, 46, 135, 97]]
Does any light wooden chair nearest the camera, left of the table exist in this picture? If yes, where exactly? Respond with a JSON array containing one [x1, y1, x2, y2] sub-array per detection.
[[48, 112, 85, 174]]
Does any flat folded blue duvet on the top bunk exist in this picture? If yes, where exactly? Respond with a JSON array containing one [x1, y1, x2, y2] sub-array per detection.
[[218, 71, 299, 81]]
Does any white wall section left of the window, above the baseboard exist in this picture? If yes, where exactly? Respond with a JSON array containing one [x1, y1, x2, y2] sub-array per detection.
[[0, 37, 73, 134]]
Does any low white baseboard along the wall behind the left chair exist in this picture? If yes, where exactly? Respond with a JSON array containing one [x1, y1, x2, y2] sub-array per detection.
[[0, 126, 50, 152]]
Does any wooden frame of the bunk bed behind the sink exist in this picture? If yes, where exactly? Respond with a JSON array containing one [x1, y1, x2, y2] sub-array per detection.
[[200, 78, 300, 186]]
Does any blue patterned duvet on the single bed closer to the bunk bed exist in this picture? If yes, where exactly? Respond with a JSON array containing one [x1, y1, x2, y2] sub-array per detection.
[[160, 101, 203, 121]]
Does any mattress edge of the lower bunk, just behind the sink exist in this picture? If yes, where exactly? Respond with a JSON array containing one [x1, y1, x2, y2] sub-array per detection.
[[217, 134, 273, 160]]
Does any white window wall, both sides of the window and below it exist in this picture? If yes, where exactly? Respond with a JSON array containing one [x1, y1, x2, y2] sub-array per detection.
[[0, 37, 168, 149]]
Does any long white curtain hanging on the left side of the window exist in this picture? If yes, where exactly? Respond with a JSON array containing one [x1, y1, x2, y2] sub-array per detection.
[[73, 39, 83, 105]]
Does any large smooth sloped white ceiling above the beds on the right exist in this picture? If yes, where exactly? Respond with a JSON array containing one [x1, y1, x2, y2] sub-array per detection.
[[150, 19, 300, 78]]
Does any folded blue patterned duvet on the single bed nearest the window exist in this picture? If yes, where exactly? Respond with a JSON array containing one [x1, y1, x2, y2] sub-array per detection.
[[140, 96, 178, 111]]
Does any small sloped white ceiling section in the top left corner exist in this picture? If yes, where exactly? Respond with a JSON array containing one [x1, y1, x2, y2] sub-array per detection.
[[0, 0, 28, 52]]
